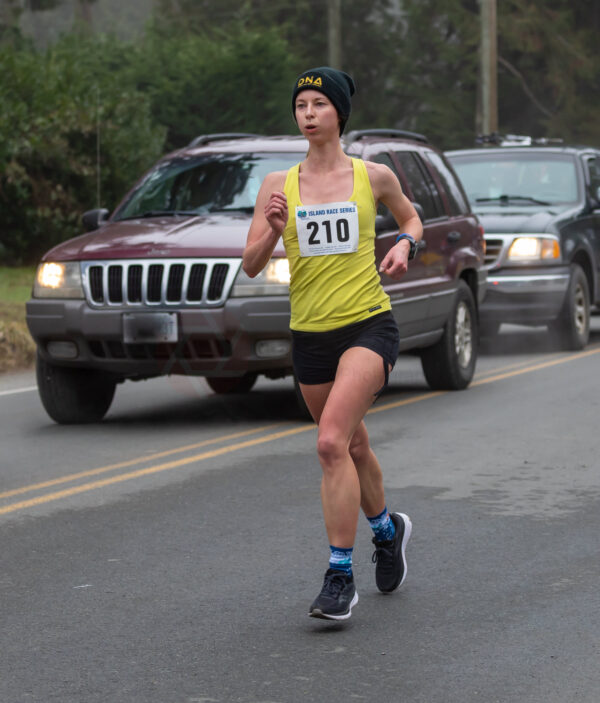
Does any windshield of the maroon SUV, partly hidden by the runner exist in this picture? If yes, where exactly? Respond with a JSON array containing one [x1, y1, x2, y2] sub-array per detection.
[[114, 153, 305, 220]]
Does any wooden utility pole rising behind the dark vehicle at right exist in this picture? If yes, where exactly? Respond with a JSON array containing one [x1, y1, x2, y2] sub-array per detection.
[[478, 0, 498, 134]]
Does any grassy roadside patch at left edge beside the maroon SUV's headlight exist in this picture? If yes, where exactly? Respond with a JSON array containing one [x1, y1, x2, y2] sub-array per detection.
[[0, 266, 35, 373]]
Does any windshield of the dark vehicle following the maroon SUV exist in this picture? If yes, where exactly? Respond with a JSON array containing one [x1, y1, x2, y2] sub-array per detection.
[[448, 152, 578, 205]]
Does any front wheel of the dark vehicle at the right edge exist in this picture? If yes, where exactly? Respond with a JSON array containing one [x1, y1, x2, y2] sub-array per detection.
[[549, 264, 590, 351]]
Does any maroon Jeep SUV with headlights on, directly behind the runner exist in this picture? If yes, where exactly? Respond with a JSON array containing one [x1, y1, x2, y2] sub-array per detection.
[[27, 130, 486, 423]]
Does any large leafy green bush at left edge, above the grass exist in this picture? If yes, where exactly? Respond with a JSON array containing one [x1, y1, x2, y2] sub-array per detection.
[[0, 36, 165, 264]]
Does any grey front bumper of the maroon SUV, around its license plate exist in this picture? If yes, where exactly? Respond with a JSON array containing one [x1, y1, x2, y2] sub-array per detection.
[[27, 296, 292, 378]]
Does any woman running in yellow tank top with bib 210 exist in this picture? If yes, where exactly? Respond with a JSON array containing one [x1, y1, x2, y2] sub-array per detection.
[[243, 67, 423, 620]]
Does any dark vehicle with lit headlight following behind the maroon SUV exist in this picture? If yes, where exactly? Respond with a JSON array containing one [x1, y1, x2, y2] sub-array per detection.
[[446, 137, 600, 350]]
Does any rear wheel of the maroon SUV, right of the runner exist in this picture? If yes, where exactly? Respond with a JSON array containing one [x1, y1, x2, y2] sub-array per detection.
[[421, 280, 478, 391]]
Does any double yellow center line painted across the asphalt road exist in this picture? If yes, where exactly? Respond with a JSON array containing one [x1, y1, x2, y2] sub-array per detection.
[[0, 347, 600, 515]]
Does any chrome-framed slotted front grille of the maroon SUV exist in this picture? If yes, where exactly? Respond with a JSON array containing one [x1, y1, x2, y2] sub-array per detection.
[[81, 259, 241, 307]]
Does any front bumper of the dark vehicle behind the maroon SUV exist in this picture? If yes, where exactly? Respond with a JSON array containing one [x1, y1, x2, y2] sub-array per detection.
[[481, 266, 570, 325]]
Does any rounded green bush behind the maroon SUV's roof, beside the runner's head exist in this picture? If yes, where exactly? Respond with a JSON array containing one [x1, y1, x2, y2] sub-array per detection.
[[132, 27, 296, 149]]
